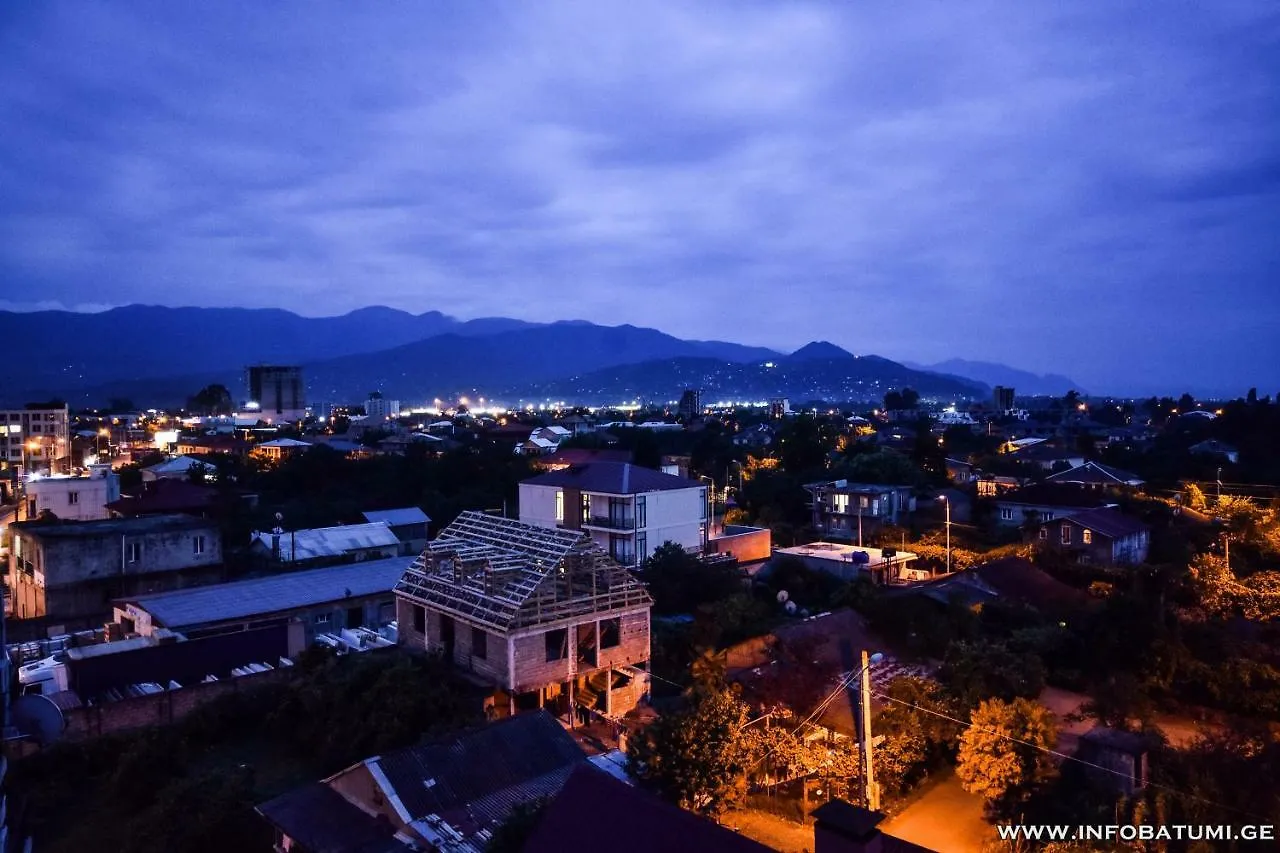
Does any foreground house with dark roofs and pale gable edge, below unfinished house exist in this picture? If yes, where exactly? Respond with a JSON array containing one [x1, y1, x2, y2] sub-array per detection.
[[270, 712, 588, 853]]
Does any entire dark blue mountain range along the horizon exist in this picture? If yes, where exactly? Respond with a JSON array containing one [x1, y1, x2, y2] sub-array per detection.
[[0, 305, 1073, 407]]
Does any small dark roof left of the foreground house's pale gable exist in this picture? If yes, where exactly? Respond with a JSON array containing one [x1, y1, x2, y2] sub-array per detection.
[[256, 783, 410, 853]]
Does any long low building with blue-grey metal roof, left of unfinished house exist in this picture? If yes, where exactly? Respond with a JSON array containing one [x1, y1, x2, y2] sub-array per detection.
[[115, 557, 407, 640]]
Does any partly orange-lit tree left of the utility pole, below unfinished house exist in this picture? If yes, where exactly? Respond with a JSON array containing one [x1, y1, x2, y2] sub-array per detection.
[[627, 688, 751, 816]]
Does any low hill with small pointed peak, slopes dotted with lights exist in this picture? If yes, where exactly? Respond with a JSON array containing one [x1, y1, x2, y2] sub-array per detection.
[[526, 353, 991, 403]]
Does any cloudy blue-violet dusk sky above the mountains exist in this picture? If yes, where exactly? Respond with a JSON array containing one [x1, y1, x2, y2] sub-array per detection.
[[0, 0, 1280, 393]]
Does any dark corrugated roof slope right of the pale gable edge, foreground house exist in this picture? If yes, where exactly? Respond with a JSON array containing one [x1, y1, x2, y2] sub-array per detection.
[[365, 711, 586, 836]]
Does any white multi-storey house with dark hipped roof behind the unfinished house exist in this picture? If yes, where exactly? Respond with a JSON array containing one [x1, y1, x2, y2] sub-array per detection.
[[520, 462, 710, 566]]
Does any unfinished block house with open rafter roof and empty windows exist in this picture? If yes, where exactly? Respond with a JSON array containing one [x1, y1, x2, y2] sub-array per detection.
[[396, 512, 653, 720]]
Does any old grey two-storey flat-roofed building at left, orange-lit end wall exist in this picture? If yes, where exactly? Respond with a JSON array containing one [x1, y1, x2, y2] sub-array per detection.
[[9, 515, 223, 624]]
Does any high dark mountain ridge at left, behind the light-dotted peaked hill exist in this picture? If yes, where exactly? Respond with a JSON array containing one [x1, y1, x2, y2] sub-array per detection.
[[0, 305, 778, 406]]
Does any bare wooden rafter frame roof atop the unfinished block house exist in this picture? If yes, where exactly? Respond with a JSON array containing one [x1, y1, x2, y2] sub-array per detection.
[[396, 511, 653, 631]]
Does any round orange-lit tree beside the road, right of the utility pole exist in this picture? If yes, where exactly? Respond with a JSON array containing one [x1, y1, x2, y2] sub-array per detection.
[[956, 699, 1057, 816]]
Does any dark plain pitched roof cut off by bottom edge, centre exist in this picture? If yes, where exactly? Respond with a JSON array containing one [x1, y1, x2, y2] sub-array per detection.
[[525, 766, 769, 853]]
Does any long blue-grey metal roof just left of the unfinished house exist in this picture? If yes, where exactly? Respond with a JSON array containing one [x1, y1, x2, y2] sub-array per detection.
[[122, 557, 410, 629]]
